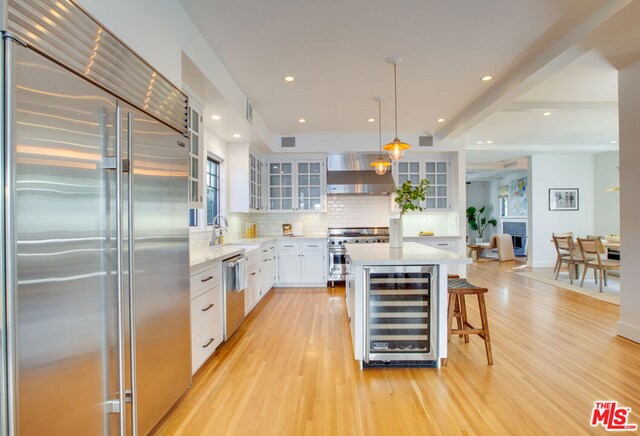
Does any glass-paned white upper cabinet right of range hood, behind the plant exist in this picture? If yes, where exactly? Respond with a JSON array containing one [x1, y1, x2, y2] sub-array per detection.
[[394, 158, 451, 210]]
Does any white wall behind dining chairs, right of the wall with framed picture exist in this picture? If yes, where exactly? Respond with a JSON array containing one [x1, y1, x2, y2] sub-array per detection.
[[594, 151, 620, 236]]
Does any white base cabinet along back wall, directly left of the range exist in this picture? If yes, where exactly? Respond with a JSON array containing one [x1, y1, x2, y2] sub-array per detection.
[[278, 239, 327, 287]]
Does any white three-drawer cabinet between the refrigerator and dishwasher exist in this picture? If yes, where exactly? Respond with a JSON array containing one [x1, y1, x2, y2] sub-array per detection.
[[191, 262, 224, 374]]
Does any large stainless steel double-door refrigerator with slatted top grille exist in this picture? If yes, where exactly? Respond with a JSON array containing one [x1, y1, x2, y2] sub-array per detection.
[[0, 0, 191, 435]]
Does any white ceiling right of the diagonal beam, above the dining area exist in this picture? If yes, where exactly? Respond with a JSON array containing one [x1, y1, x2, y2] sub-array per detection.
[[466, 50, 618, 154]]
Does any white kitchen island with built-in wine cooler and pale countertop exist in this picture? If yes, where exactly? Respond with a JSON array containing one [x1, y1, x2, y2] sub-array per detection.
[[346, 242, 471, 368]]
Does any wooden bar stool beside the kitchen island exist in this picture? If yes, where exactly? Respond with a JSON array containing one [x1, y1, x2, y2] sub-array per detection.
[[447, 278, 493, 365]]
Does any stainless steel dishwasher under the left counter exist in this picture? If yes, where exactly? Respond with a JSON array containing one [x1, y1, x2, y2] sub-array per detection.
[[222, 255, 247, 341]]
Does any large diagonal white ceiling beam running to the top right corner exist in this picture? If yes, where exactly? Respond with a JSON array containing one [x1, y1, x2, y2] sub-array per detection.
[[434, 0, 634, 140]]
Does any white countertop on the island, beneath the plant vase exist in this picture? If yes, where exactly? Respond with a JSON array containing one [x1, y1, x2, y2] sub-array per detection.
[[346, 242, 471, 265]]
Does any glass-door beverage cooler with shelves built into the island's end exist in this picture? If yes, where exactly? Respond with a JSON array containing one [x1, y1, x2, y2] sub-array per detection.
[[362, 265, 438, 367]]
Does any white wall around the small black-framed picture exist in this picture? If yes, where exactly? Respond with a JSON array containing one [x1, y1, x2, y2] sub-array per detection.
[[529, 154, 595, 267]]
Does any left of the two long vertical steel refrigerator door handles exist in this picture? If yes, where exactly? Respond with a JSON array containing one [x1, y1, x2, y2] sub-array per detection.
[[116, 103, 126, 435]]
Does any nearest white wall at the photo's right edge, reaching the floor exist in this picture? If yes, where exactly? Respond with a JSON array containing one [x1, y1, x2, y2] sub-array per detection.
[[618, 61, 640, 342]]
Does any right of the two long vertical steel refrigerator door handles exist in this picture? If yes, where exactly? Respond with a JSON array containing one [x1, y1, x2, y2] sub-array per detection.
[[127, 112, 138, 436]]
